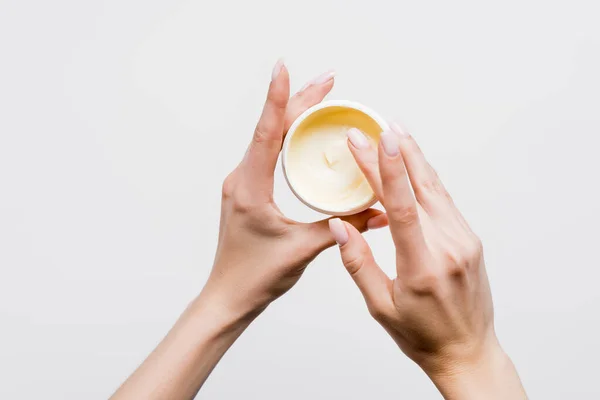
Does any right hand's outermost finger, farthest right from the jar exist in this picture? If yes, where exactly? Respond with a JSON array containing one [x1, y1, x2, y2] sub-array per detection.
[[390, 123, 453, 217]]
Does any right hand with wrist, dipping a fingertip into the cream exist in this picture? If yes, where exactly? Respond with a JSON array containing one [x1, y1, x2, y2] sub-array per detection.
[[330, 124, 527, 400]]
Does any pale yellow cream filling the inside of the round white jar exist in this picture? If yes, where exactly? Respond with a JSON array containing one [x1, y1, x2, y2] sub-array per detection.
[[286, 107, 381, 212]]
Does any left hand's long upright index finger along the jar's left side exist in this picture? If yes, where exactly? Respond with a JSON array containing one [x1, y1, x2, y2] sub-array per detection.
[[243, 60, 290, 194]]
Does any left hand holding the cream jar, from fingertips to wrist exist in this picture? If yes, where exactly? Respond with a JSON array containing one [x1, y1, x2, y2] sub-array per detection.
[[202, 62, 381, 322]]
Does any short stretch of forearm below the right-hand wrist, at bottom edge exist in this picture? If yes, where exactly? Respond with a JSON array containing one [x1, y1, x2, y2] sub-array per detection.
[[429, 346, 527, 400]]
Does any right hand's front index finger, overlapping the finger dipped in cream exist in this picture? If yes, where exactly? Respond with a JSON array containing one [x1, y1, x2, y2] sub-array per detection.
[[379, 130, 425, 264]]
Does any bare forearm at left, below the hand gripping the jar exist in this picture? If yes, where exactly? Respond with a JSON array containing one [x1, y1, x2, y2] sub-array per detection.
[[112, 294, 254, 400]]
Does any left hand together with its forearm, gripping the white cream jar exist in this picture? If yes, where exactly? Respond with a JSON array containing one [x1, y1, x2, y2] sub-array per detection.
[[112, 62, 385, 400]]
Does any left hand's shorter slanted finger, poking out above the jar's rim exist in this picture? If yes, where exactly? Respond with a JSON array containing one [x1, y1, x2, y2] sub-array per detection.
[[284, 71, 335, 133]]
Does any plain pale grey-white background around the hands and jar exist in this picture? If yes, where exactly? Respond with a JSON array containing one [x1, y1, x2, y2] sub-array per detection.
[[0, 0, 600, 400]]
